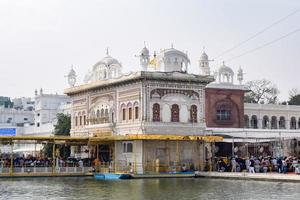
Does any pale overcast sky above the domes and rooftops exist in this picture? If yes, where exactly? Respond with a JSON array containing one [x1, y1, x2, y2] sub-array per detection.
[[0, 0, 300, 101]]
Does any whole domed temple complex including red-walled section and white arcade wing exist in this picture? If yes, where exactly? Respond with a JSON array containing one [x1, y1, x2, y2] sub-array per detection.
[[65, 46, 300, 173]]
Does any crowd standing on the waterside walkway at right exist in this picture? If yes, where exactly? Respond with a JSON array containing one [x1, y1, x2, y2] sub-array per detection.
[[215, 156, 300, 174]]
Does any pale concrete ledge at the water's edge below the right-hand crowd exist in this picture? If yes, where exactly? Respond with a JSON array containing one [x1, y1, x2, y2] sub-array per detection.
[[195, 172, 300, 182]]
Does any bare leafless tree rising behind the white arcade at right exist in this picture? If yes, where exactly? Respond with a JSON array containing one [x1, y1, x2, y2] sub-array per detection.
[[245, 79, 279, 104]]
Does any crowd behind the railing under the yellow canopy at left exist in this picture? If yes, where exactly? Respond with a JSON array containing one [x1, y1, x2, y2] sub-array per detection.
[[0, 154, 92, 168]]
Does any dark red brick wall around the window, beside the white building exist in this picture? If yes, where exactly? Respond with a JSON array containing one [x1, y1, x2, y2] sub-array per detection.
[[205, 88, 244, 128]]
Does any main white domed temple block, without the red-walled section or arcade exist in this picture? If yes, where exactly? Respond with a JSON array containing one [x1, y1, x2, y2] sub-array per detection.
[[65, 47, 223, 173]]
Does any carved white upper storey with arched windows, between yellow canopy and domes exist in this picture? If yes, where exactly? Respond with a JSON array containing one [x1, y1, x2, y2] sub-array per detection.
[[66, 72, 212, 136]]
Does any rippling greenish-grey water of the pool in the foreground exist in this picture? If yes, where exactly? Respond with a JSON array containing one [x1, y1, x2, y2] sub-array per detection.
[[0, 177, 300, 200]]
